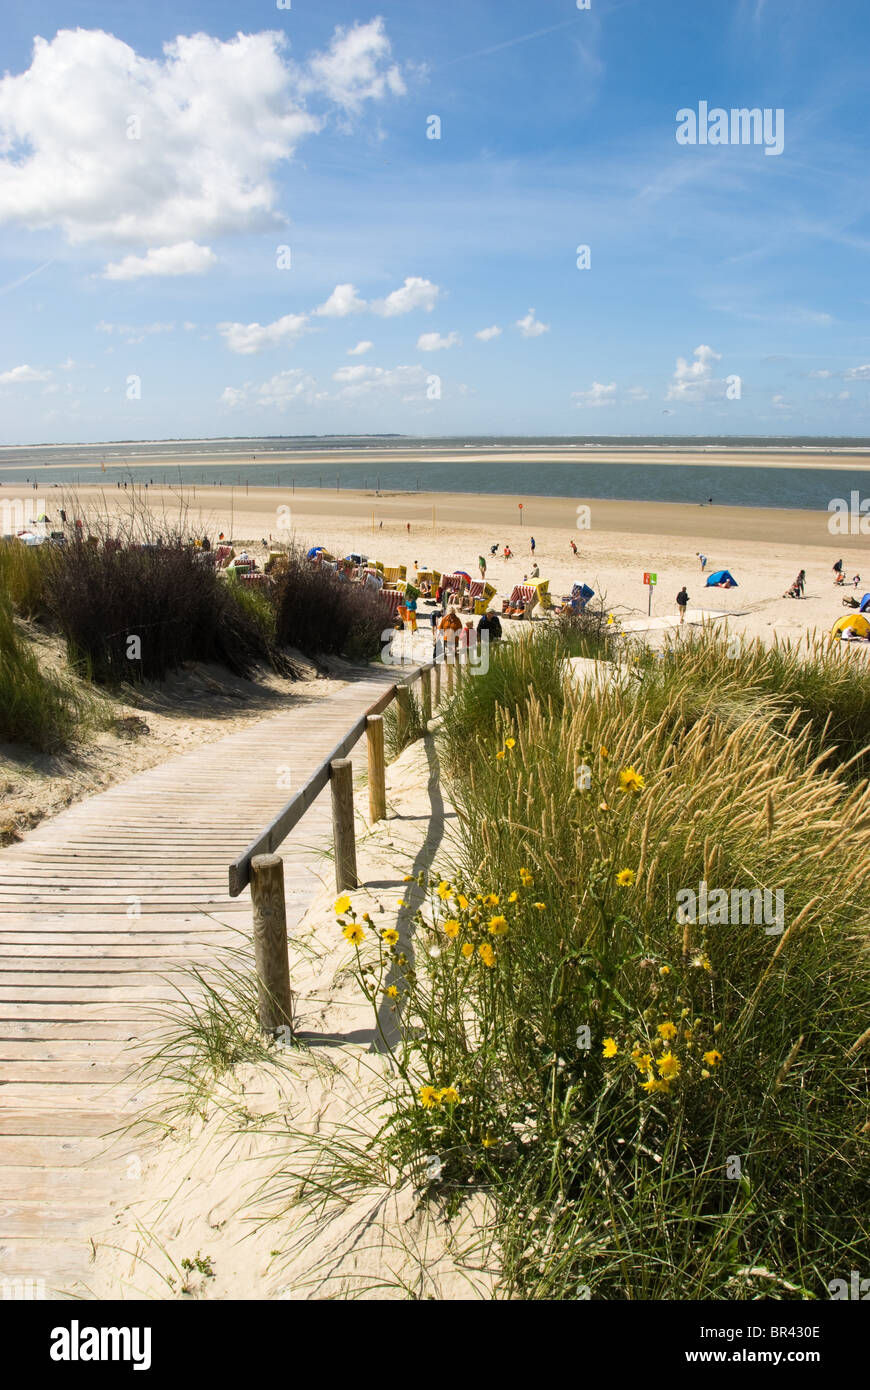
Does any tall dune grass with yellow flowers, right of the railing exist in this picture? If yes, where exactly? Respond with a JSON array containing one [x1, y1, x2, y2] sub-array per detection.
[[330, 625, 870, 1300]]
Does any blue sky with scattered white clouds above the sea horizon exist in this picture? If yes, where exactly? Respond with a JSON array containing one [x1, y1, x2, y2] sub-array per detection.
[[0, 0, 870, 443]]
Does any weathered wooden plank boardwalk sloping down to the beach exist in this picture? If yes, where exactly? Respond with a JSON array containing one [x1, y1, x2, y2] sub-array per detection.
[[0, 676, 391, 1298]]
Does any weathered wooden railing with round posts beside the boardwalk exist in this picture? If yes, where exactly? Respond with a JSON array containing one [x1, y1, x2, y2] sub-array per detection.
[[229, 652, 464, 1033]]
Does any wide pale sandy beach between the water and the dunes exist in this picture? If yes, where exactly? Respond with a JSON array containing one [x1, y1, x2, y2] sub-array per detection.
[[8, 485, 870, 639]]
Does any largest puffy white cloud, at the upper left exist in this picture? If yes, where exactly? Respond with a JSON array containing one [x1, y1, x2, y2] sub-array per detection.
[[0, 19, 404, 247]]
